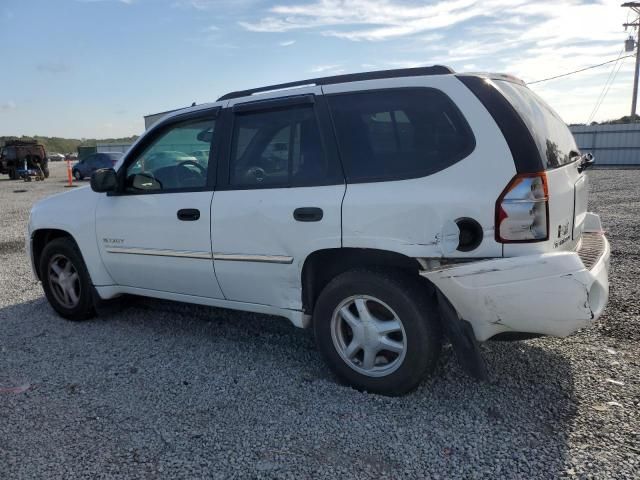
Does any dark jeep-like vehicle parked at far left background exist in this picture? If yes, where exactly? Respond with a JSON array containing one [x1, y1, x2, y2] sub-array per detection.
[[0, 140, 49, 180]]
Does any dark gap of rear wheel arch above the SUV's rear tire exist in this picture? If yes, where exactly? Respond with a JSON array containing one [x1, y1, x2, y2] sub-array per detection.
[[301, 247, 430, 314]]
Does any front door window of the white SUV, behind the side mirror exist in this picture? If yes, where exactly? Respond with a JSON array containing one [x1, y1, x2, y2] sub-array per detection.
[[126, 119, 215, 192]]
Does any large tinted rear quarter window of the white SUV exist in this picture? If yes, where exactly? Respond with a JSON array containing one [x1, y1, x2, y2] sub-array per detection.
[[329, 88, 475, 182]]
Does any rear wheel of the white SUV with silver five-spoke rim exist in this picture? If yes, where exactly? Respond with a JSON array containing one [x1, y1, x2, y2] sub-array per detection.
[[313, 270, 441, 395]]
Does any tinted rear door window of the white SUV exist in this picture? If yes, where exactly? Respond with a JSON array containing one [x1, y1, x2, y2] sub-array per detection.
[[229, 105, 332, 188]]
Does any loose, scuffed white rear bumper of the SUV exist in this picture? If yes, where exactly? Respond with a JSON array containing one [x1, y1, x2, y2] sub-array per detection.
[[421, 213, 611, 341]]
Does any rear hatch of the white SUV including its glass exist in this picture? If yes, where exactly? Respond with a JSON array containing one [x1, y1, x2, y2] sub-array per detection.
[[494, 79, 588, 256]]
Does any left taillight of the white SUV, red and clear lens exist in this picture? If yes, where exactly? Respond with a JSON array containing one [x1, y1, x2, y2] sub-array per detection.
[[496, 172, 549, 243]]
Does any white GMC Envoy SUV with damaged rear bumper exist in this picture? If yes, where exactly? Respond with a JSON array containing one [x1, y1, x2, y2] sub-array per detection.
[[27, 66, 610, 394]]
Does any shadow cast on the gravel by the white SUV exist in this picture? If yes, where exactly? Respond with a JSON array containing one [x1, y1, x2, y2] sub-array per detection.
[[0, 298, 576, 478]]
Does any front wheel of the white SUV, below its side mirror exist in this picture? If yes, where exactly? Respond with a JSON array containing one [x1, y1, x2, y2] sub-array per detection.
[[40, 238, 95, 321]]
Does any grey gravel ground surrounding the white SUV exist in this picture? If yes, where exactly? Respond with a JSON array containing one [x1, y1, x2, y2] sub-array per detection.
[[0, 164, 640, 479]]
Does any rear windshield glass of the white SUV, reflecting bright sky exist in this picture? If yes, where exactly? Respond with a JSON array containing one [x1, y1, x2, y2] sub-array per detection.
[[495, 80, 580, 169]]
